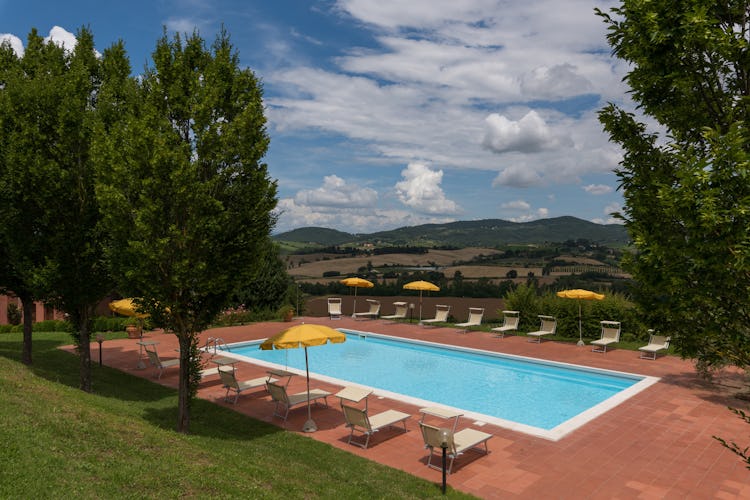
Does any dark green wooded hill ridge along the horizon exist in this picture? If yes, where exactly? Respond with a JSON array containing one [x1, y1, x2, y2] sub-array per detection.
[[273, 216, 630, 247]]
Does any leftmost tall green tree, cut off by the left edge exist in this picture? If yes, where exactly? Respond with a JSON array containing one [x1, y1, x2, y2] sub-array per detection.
[[0, 35, 52, 365]]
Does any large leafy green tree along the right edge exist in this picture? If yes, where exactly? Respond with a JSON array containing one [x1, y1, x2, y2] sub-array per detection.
[[598, 0, 750, 372]]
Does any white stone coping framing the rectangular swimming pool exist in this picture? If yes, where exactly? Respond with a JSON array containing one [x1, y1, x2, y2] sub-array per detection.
[[210, 328, 659, 441]]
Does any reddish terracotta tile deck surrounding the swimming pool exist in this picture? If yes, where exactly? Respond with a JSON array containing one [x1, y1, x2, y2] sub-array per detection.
[[83, 317, 750, 499]]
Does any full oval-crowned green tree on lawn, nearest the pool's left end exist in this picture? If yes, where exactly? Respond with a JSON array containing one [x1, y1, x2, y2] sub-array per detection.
[[97, 30, 276, 432]]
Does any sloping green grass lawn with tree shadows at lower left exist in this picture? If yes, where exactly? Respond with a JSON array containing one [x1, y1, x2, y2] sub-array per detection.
[[0, 333, 471, 499]]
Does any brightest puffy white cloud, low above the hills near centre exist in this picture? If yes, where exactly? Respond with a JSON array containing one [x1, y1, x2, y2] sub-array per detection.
[[396, 163, 459, 214]]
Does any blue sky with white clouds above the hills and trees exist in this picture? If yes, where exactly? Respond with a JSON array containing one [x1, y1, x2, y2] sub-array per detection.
[[0, 0, 632, 233]]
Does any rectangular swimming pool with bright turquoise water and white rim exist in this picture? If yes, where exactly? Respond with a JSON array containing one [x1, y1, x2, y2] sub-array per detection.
[[222, 330, 657, 440]]
